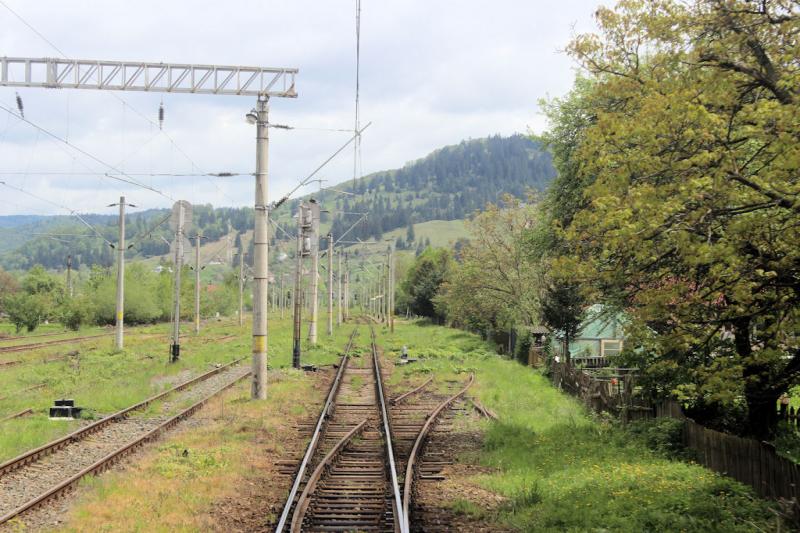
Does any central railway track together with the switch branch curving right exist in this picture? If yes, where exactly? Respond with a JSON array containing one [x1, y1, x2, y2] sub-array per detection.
[[275, 325, 474, 533]]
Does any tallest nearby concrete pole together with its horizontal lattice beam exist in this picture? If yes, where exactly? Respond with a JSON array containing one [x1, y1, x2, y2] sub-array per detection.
[[0, 57, 298, 398]]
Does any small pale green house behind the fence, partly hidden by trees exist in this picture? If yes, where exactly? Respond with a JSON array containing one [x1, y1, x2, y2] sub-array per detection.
[[555, 304, 625, 368]]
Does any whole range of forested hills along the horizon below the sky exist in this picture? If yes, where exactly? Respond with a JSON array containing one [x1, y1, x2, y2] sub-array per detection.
[[0, 135, 554, 270]]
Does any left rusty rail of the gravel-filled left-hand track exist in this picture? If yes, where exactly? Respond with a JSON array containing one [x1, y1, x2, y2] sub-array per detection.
[[0, 357, 246, 477]]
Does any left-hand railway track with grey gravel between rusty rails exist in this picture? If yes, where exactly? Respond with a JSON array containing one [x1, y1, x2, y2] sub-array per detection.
[[0, 359, 250, 524]]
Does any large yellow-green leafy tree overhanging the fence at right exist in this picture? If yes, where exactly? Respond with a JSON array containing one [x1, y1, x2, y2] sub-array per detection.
[[556, 0, 800, 438]]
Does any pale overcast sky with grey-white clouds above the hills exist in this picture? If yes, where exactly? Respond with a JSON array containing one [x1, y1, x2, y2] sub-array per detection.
[[0, 0, 599, 215]]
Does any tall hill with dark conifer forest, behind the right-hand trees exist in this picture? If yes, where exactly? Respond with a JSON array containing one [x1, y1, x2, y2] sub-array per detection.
[[320, 135, 555, 239]]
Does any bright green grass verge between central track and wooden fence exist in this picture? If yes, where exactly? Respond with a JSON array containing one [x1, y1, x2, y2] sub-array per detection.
[[382, 323, 775, 532]]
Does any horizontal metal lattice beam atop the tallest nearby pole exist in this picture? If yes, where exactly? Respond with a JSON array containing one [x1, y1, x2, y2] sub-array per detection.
[[0, 57, 298, 98]]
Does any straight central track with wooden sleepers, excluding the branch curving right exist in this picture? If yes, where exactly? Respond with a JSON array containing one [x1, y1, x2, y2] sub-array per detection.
[[276, 329, 402, 533]]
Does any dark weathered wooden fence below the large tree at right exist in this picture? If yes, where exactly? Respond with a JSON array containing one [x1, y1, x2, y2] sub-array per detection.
[[553, 363, 800, 508]]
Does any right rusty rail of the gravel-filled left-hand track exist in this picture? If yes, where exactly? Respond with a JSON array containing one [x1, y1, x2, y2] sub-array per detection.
[[0, 361, 250, 524]]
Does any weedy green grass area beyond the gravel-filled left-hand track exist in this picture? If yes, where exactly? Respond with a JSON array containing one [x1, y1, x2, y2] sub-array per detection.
[[0, 315, 345, 462]]
